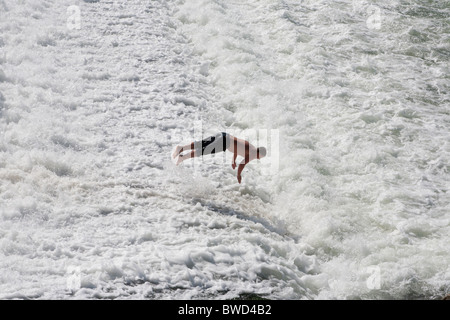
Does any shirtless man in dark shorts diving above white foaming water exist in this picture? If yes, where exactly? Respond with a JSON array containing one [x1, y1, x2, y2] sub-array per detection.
[[172, 132, 267, 183]]
